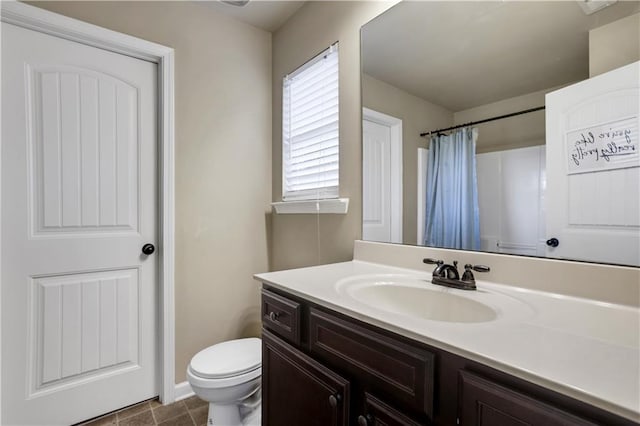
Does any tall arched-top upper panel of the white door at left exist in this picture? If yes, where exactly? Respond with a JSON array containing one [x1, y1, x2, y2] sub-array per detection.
[[27, 67, 139, 235]]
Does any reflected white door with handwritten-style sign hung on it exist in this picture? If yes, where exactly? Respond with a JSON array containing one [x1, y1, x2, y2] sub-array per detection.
[[546, 62, 640, 265]]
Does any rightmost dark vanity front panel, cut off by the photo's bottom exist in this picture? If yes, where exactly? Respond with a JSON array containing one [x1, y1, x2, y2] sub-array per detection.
[[459, 371, 593, 426]]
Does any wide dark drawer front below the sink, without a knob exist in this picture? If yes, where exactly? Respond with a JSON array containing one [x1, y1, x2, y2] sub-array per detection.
[[309, 308, 434, 419]]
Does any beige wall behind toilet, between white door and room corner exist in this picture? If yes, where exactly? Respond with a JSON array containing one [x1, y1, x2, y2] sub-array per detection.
[[28, 2, 271, 382]]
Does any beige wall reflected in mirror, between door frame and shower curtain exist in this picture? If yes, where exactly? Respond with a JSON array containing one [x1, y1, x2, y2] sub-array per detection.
[[362, 74, 453, 244]]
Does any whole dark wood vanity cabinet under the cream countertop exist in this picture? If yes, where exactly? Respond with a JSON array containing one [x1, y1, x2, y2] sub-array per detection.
[[262, 285, 636, 426]]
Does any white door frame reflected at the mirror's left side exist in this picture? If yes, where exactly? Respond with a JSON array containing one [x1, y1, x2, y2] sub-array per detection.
[[362, 108, 402, 243]]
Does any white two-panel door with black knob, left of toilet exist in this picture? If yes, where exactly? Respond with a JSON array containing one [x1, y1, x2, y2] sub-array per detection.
[[2, 24, 158, 425]]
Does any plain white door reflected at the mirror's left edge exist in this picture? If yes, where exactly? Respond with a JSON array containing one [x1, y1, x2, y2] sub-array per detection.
[[362, 120, 391, 243]]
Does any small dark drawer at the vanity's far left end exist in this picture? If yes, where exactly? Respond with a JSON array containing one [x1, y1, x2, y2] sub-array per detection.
[[262, 289, 301, 346]]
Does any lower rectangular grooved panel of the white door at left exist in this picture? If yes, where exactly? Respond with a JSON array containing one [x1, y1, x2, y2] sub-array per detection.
[[31, 269, 139, 394]]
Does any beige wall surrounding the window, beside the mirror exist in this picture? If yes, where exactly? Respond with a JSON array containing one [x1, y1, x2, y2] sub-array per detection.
[[271, 1, 395, 270]]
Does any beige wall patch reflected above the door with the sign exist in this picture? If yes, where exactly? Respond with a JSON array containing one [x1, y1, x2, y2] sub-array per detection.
[[589, 13, 640, 77]]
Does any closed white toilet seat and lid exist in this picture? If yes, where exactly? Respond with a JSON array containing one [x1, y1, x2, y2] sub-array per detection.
[[187, 337, 262, 387]]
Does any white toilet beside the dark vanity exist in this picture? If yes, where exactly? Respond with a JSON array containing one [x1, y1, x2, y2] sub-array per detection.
[[187, 337, 262, 426]]
